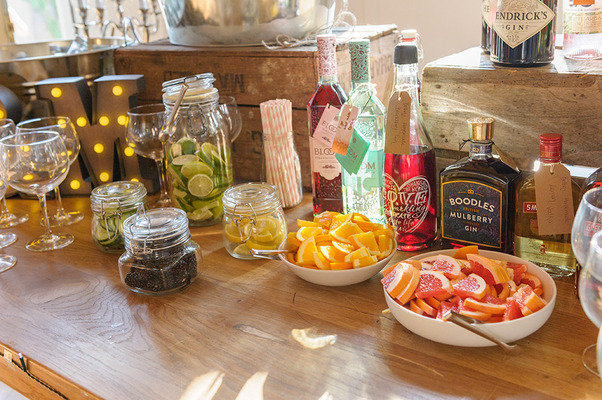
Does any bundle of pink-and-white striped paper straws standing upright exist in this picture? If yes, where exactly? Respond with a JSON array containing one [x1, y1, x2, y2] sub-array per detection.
[[259, 99, 303, 208]]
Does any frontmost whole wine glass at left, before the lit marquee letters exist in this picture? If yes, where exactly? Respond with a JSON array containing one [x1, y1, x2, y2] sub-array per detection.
[[0, 130, 73, 251]]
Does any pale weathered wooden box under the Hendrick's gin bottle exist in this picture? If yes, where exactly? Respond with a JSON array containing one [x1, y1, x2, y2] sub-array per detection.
[[422, 48, 602, 168]]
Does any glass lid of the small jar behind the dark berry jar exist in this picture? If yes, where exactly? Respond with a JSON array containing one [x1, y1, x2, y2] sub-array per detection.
[[90, 181, 146, 213]]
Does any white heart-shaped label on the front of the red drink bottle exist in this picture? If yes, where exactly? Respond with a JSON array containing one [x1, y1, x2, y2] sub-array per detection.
[[385, 174, 432, 233]]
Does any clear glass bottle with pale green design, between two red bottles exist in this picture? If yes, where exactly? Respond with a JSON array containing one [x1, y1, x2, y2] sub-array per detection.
[[342, 39, 387, 223]]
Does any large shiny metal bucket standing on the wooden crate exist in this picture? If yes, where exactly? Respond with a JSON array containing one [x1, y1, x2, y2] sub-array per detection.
[[159, 0, 336, 46]]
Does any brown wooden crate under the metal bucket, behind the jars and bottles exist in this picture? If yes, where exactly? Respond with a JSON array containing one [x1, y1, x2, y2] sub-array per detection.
[[114, 25, 398, 188]]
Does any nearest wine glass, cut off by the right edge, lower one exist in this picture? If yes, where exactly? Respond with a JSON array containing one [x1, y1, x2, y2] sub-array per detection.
[[579, 231, 602, 376]]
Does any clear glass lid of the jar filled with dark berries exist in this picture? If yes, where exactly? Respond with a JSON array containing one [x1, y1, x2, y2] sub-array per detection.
[[123, 207, 190, 254]]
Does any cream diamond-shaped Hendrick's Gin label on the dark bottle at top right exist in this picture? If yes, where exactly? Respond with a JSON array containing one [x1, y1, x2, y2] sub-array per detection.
[[492, 0, 556, 48]]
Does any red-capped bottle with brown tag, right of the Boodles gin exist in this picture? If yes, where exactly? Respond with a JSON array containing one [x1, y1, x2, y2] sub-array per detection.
[[514, 133, 581, 276]]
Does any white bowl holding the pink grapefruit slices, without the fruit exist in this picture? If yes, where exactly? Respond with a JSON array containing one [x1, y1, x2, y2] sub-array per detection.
[[383, 250, 556, 347]]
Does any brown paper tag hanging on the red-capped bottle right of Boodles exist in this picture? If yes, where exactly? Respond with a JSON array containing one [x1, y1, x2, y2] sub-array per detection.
[[535, 164, 575, 235]]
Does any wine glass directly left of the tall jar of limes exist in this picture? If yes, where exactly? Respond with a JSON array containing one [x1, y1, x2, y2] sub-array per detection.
[[125, 104, 172, 207]]
